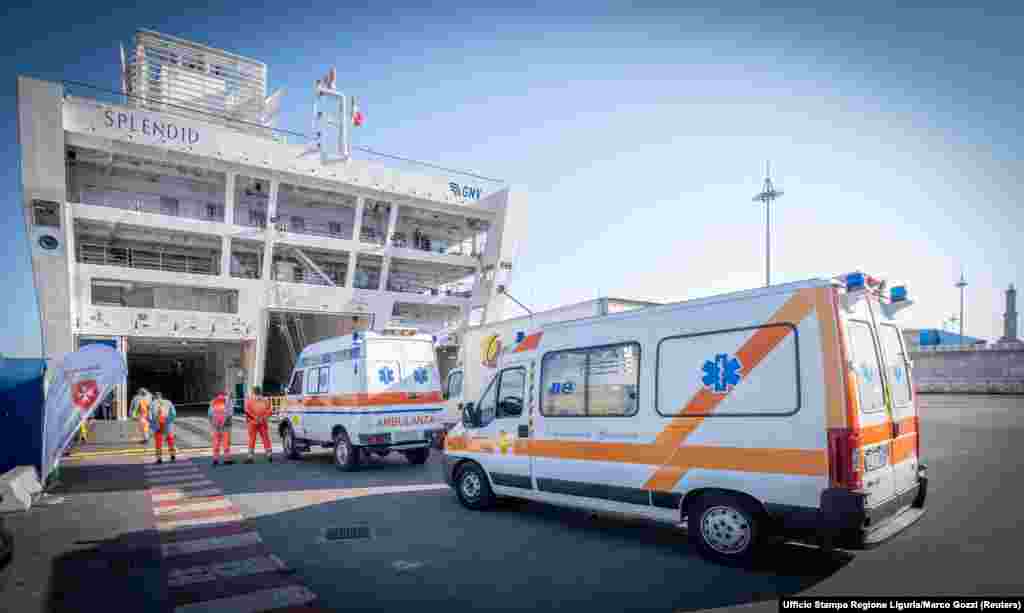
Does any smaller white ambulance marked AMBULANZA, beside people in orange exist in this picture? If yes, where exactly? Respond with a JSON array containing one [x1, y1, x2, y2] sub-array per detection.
[[280, 329, 443, 471]]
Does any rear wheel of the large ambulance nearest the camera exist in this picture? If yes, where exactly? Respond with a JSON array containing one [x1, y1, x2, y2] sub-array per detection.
[[686, 494, 765, 566]]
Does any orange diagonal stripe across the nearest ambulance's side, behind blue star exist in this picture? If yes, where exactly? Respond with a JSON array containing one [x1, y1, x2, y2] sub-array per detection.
[[644, 290, 814, 491]]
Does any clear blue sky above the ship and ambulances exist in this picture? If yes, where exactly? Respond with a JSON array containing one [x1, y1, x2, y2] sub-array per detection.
[[0, 2, 1024, 355]]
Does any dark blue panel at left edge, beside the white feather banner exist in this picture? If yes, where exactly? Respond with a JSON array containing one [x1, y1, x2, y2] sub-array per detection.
[[0, 358, 46, 479]]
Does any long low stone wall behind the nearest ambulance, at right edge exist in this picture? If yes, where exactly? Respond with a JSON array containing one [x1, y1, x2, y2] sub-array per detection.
[[910, 345, 1024, 394]]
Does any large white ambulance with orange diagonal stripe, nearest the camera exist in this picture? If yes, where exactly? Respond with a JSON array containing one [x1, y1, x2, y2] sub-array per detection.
[[443, 272, 927, 563]]
